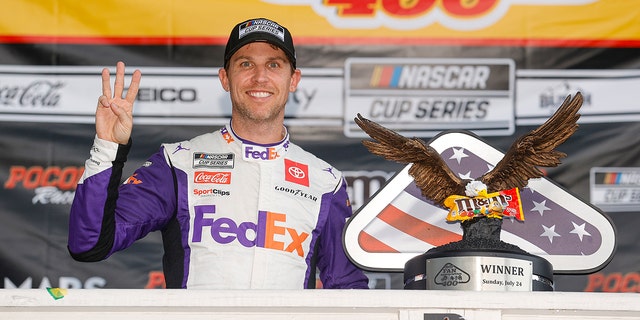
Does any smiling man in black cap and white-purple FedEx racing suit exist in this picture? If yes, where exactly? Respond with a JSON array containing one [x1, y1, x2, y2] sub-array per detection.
[[68, 18, 368, 289]]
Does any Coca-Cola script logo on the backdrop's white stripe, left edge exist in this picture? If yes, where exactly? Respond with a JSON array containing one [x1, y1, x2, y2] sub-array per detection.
[[0, 80, 64, 107]]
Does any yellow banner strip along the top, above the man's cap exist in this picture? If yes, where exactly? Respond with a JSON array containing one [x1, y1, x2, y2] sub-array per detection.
[[5, 0, 640, 46]]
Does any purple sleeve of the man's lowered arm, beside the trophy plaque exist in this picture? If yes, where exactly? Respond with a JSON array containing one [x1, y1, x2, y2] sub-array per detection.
[[318, 179, 369, 289]]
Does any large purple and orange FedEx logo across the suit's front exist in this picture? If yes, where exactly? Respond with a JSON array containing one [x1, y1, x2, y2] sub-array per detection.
[[191, 205, 309, 257]]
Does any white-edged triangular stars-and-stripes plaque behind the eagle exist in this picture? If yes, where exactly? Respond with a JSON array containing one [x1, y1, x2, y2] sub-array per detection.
[[344, 132, 616, 273]]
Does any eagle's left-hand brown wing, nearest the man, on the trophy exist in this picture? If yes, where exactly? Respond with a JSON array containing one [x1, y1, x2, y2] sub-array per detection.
[[354, 114, 466, 206]]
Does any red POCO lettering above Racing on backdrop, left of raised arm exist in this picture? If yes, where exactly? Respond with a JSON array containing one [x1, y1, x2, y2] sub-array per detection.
[[4, 166, 84, 190]]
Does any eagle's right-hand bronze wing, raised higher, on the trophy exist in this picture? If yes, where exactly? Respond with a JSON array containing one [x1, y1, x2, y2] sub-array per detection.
[[479, 92, 583, 192]]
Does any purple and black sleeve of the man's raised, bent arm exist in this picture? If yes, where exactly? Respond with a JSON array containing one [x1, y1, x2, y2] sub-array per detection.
[[68, 144, 176, 261]]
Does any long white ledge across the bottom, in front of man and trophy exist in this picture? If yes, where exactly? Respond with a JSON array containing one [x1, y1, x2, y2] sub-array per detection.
[[0, 289, 640, 320]]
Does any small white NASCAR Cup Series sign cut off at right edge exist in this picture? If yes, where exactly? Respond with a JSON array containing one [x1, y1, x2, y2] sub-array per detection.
[[589, 167, 640, 212]]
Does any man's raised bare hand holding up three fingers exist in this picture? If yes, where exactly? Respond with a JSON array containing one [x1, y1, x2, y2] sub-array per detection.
[[96, 61, 142, 144]]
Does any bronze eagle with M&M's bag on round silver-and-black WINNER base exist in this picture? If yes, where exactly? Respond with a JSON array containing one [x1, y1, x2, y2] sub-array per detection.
[[354, 92, 583, 291]]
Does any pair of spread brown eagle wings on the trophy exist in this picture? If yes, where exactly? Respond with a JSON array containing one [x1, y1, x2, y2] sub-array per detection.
[[354, 92, 583, 207]]
